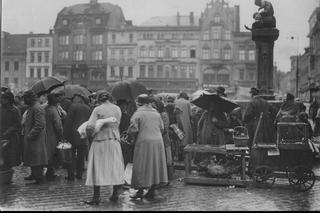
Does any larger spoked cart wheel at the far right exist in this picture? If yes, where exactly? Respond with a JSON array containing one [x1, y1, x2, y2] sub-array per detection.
[[288, 166, 316, 192]]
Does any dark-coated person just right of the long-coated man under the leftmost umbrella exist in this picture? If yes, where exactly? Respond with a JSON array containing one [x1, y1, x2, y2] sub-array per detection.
[[45, 94, 63, 179]]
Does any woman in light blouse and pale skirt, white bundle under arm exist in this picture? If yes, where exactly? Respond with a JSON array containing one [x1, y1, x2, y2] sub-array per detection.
[[85, 91, 125, 205]]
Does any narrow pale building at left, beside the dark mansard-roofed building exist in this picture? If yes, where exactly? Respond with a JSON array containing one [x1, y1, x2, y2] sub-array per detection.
[[26, 34, 53, 87]]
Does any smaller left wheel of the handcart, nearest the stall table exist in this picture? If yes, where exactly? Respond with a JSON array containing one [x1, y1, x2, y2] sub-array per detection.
[[252, 166, 276, 187]]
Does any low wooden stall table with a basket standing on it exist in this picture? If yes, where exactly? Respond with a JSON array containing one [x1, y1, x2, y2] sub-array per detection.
[[184, 144, 249, 186]]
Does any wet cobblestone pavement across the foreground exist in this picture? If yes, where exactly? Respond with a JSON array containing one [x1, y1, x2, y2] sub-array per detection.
[[0, 163, 320, 211]]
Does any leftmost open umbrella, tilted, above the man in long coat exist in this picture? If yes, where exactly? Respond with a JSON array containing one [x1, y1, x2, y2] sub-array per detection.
[[31, 76, 66, 95]]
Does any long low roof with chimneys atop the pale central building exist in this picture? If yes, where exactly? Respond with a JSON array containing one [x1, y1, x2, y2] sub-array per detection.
[[141, 16, 200, 27]]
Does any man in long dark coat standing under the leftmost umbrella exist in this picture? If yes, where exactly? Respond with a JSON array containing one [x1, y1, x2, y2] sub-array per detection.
[[23, 91, 48, 184]]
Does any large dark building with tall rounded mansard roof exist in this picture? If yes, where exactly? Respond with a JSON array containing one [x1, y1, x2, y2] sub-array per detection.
[[53, 0, 126, 90]]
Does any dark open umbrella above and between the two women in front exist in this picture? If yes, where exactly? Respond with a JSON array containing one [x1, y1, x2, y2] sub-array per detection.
[[112, 81, 148, 100]]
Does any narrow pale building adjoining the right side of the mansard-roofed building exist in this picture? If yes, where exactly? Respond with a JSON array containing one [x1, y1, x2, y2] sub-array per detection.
[[107, 21, 138, 85]]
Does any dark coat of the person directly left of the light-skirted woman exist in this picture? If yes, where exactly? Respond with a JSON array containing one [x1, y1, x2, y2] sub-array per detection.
[[64, 103, 91, 146]]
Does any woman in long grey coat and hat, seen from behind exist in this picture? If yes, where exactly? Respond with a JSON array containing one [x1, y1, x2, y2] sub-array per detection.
[[128, 94, 168, 199]]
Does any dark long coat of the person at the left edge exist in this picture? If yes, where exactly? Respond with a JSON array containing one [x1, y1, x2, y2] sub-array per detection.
[[1, 106, 22, 167]]
